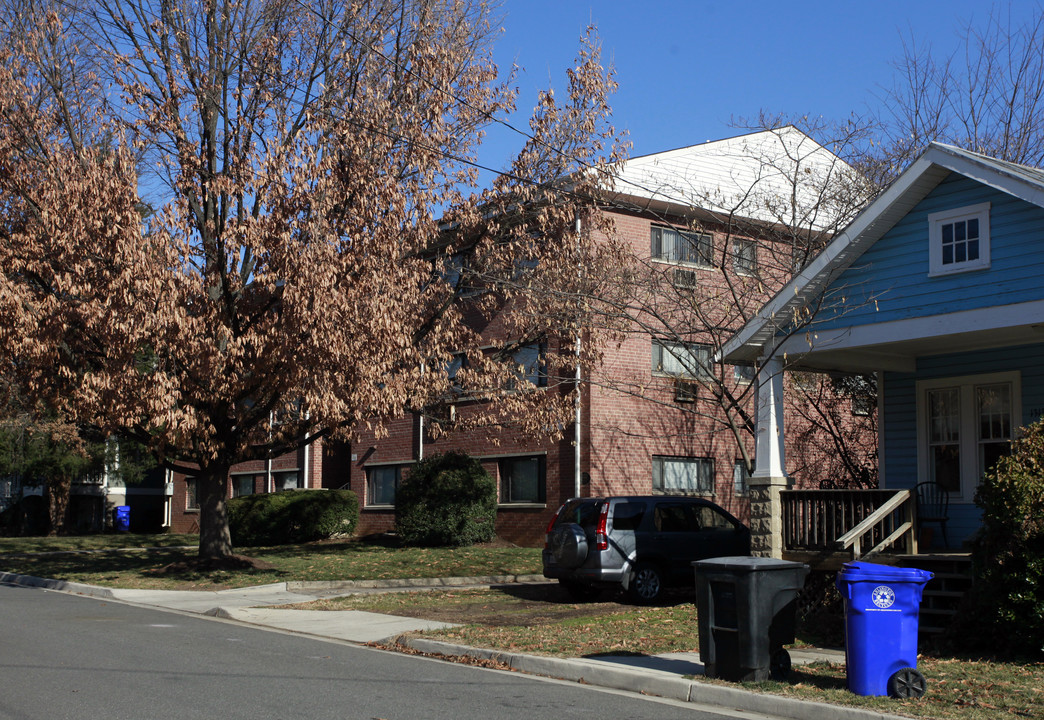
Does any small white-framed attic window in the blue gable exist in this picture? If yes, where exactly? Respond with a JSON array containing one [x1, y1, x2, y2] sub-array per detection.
[[928, 202, 990, 275]]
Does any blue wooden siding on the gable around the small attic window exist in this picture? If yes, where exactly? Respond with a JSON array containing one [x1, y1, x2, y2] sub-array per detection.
[[816, 174, 1044, 329]]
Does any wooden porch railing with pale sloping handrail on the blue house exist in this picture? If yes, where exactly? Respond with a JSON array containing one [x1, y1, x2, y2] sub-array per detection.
[[781, 490, 917, 559]]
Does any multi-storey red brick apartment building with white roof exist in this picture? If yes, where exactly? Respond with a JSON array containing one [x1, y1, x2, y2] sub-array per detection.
[[163, 127, 872, 545]]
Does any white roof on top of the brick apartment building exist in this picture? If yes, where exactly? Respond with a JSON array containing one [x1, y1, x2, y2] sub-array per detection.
[[614, 125, 854, 230]]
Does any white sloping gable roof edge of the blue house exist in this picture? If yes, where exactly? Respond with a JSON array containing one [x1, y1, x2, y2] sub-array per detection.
[[720, 143, 1044, 362]]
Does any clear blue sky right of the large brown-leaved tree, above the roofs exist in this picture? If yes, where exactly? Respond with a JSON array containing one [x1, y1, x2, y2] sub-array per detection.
[[480, 0, 1042, 168]]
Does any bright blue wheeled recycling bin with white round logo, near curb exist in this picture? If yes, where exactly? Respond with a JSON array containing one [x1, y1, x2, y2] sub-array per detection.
[[836, 562, 934, 697]]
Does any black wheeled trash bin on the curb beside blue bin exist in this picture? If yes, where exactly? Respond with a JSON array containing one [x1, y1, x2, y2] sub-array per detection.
[[692, 556, 808, 682]]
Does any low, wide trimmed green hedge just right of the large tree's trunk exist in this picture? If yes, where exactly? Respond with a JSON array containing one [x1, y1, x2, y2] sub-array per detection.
[[229, 490, 359, 546]]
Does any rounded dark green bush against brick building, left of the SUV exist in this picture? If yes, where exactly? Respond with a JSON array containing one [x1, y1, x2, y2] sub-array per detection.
[[395, 453, 497, 547]]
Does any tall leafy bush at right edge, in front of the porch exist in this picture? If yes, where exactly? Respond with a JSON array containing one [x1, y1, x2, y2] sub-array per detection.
[[956, 421, 1044, 656]]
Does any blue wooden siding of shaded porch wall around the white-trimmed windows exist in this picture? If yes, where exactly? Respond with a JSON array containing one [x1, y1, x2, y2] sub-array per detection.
[[881, 344, 1044, 546]]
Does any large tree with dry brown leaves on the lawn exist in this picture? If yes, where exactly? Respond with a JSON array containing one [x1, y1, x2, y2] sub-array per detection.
[[0, 0, 616, 558]]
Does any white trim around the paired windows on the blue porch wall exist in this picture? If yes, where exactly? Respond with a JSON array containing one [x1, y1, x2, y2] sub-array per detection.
[[917, 370, 1022, 503]]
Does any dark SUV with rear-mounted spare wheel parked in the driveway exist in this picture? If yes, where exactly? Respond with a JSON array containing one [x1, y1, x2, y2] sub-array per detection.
[[543, 496, 751, 603]]
